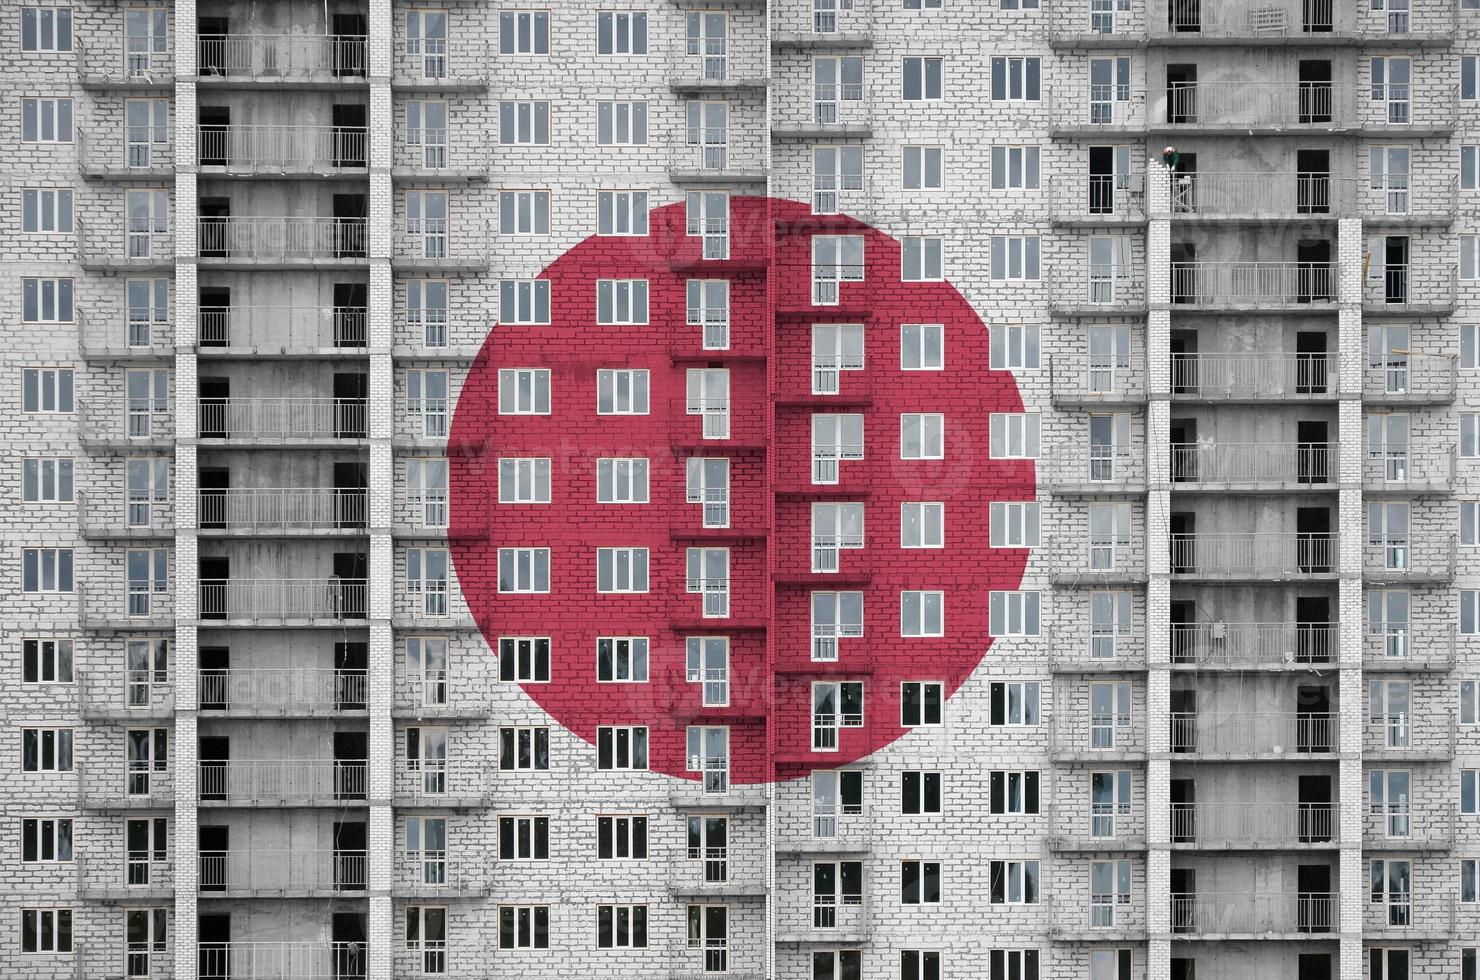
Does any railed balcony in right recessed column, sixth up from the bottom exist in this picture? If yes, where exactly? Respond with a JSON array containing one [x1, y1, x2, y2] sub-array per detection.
[[1168, 443, 1341, 493]]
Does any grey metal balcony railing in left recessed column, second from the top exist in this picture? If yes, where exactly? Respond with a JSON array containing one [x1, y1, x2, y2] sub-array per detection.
[[197, 124, 370, 172]]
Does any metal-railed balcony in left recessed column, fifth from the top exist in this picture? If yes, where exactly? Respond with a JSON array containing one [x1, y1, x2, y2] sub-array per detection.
[[197, 398, 366, 446]]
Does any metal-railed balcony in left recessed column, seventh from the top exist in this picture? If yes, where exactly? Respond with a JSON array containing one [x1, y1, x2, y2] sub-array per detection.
[[198, 577, 367, 626]]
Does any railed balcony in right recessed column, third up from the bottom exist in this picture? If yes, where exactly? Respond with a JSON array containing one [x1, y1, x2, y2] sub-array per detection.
[[1169, 711, 1338, 759]]
